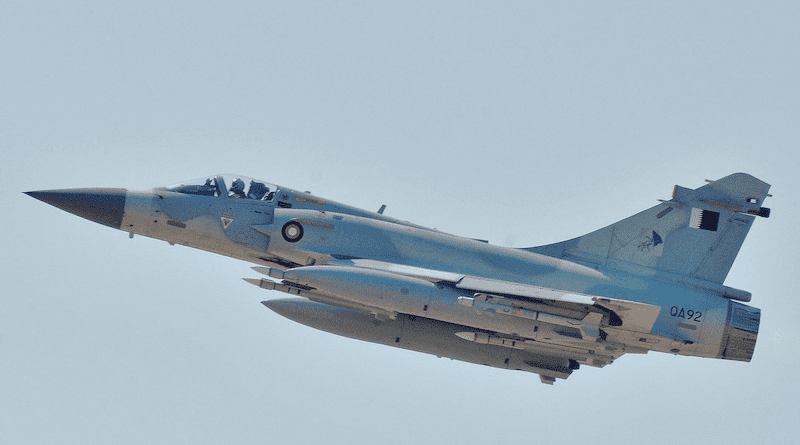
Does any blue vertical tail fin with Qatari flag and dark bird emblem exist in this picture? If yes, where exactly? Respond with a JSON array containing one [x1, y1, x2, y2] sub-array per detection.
[[525, 173, 770, 284]]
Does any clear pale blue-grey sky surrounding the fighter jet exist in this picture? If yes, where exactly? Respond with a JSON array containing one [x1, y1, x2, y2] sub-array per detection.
[[0, 0, 800, 444]]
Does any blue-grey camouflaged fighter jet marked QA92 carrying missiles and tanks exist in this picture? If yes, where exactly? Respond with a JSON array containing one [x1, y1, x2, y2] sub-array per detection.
[[27, 173, 770, 384]]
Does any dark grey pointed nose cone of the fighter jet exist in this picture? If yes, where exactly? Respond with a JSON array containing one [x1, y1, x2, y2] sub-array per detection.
[[25, 188, 128, 229]]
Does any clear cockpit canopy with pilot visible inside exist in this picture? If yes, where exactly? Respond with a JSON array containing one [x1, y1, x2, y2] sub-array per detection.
[[163, 173, 278, 201]]
